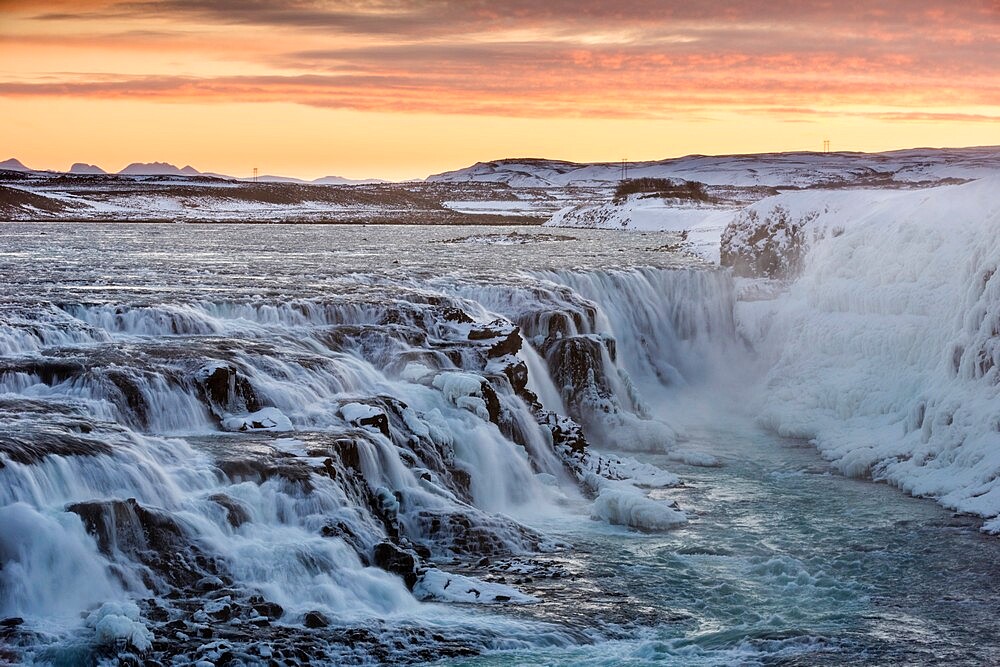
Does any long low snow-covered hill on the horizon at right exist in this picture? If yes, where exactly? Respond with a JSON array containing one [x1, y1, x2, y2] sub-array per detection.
[[427, 146, 1000, 188]]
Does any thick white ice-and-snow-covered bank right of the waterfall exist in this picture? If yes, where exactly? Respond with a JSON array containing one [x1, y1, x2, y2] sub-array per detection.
[[738, 177, 1000, 531]]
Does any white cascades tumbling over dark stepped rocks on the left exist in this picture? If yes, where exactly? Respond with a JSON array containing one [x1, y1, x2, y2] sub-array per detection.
[[0, 227, 721, 663]]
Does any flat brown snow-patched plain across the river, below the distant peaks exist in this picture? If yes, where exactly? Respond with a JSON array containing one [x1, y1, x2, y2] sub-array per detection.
[[0, 170, 559, 224]]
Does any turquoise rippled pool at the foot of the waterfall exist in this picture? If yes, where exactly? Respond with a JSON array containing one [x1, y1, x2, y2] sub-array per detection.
[[444, 424, 1000, 666]]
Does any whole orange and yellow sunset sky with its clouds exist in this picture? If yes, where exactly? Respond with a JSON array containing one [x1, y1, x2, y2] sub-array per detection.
[[0, 0, 1000, 178]]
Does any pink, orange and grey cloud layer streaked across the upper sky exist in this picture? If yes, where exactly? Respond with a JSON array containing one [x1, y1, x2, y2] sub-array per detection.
[[0, 0, 1000, 122]]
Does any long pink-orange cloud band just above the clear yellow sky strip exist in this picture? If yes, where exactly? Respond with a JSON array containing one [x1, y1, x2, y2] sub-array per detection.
[[0, 70, 1000, 121]]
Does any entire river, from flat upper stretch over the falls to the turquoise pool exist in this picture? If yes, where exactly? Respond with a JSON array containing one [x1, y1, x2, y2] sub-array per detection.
[[0, 224, 1000, 665]]
